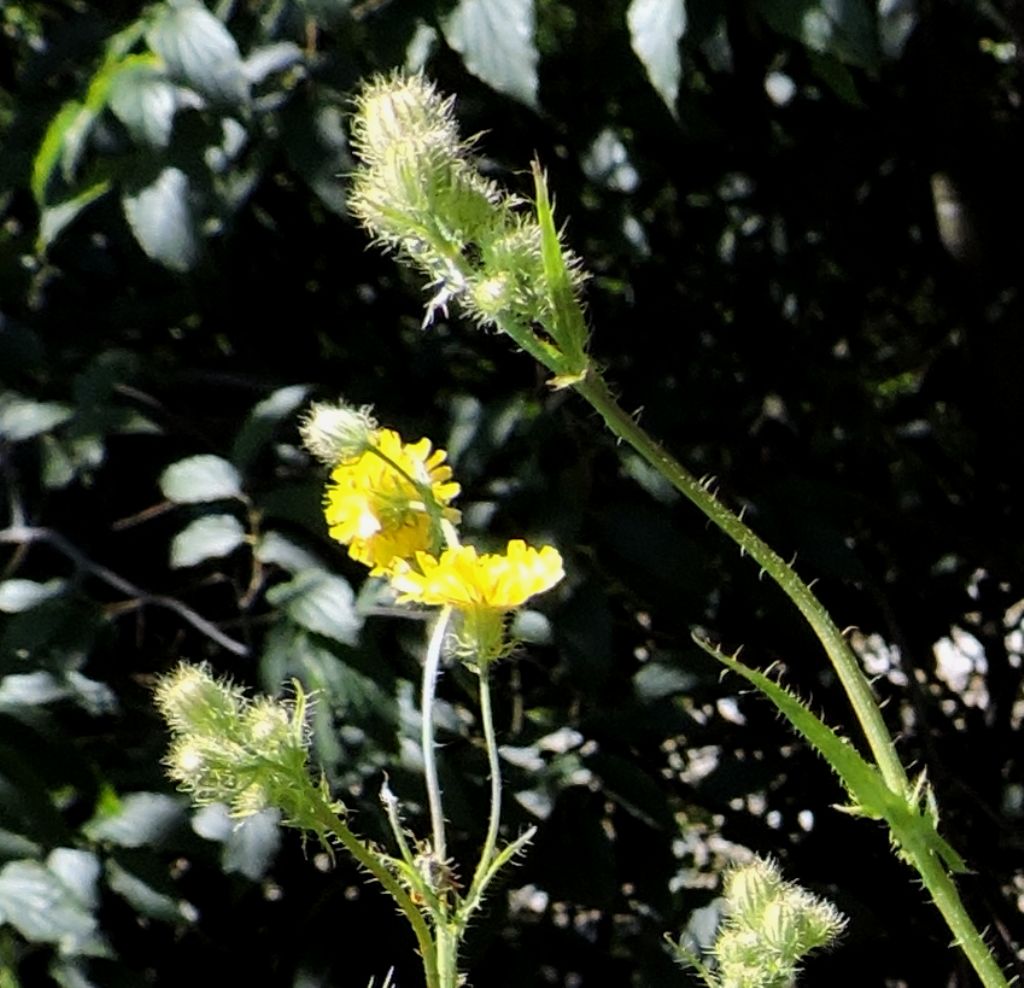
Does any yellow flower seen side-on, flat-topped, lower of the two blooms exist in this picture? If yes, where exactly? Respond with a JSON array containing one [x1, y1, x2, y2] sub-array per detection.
[[391, 539, 565, 612]]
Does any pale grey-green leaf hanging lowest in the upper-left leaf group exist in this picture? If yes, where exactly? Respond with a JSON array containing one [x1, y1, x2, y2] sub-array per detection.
[[121, 168, 200, 271]]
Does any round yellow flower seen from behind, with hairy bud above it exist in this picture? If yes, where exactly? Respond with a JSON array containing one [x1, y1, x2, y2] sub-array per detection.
[[324, 429, 460, 574]]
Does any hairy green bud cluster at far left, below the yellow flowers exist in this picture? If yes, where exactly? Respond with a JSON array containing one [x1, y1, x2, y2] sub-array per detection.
[[156, 663, 312, 822]]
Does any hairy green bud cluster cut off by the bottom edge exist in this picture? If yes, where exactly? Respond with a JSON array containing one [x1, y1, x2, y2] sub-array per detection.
[[677, 858, 846, 988]]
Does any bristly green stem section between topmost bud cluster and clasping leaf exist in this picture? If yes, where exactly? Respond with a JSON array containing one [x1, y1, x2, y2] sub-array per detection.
[[573, 369, 909, 796]]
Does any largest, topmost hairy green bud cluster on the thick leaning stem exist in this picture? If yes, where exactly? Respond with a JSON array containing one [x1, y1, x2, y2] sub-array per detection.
[[350, 74, 583, 344]]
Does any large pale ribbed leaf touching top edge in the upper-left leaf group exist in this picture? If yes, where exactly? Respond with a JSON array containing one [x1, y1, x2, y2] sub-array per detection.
[[146, 0, 249, 106]]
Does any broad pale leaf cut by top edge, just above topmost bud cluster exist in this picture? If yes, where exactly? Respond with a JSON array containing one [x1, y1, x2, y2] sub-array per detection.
[[441, 0, 539, 106]]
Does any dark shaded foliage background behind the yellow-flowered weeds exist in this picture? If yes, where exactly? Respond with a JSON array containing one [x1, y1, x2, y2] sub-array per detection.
[[0, 0, 1024, 986]]
